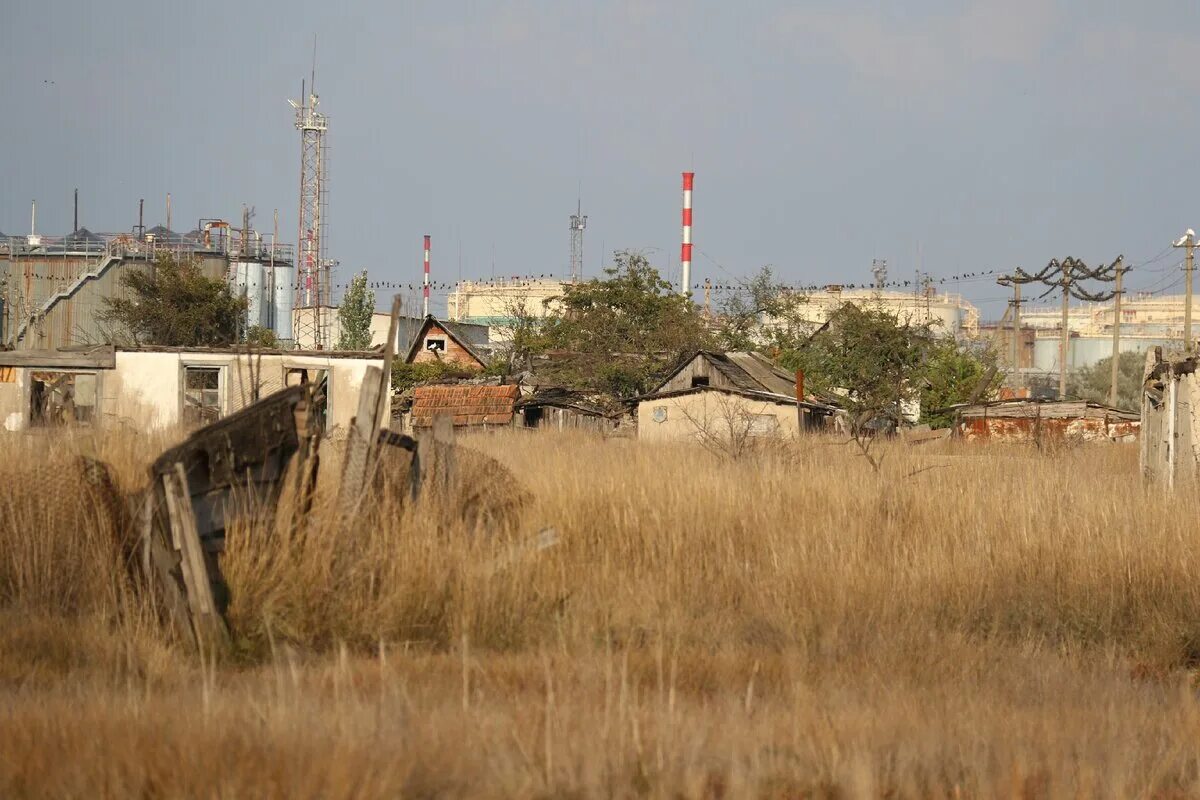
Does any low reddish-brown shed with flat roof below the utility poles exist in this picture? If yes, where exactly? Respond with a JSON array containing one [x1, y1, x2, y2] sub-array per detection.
[[956, 399, 1141, 444]]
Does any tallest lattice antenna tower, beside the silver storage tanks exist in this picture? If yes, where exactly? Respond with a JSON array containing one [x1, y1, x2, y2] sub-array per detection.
[[288, 55, 332, 350]]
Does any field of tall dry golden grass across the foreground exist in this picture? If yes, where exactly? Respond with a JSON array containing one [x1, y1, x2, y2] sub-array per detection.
[[0, 434, 1200, 798]]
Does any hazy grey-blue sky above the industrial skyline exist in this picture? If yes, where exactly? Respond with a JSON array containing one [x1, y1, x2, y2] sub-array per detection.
[[0, 0, 1200, 318]]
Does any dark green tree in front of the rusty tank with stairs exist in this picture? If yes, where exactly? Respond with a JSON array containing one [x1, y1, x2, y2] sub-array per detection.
[[100, 253, 247, 347]]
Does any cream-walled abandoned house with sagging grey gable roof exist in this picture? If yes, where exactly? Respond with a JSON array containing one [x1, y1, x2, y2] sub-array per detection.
[[637, 350, 835, 441]]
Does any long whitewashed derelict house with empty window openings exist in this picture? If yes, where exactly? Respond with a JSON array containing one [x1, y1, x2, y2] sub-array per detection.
[[0, 345, 383, 433]]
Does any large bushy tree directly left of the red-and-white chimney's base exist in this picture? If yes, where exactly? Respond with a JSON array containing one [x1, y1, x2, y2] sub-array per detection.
[[537, 251, 713, 397]]
